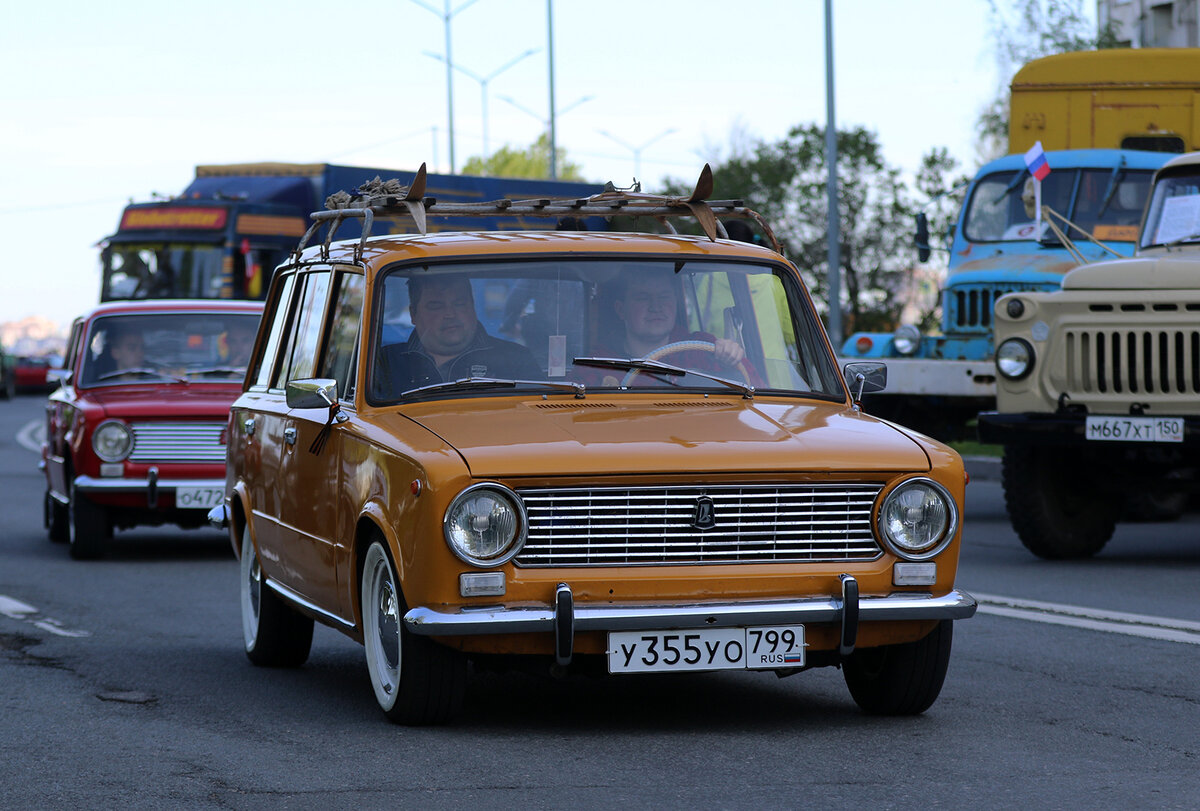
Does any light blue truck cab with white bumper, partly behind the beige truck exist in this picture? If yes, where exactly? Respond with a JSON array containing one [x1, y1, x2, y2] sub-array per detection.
[[840, 149, 1171, 439]]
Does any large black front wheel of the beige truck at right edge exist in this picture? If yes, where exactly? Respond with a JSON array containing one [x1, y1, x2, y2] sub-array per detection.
[[1001, 445, 1122, 560]]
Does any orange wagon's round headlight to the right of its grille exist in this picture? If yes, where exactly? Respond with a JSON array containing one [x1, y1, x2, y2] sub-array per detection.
[[878, 479, 959, 560]]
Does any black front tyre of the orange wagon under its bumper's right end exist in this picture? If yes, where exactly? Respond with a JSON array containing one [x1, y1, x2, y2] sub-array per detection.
[[842, 619, 954, 715]]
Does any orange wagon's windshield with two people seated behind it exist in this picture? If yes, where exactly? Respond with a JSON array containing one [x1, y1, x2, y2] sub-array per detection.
[[370, 259, 845, 402]]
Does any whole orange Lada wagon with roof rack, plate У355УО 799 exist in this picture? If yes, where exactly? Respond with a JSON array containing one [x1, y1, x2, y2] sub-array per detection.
[[210, 169, 976, 723]]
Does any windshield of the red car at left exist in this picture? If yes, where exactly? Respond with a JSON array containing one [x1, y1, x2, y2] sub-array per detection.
[[77, 312, 259, 386]]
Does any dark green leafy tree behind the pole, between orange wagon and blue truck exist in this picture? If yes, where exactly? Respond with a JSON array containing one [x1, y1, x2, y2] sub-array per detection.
[[667, 124, 956, 335]]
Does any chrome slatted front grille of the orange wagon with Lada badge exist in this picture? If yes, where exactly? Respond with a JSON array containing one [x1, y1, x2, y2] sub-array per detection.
[[516, 485, 882, 566]]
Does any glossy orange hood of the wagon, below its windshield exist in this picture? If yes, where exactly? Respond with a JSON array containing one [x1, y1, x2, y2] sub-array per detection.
[[404, 397, 930, 477]]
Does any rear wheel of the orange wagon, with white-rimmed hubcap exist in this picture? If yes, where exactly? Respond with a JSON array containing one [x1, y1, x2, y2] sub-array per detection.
[[240, 523, 312, 667]]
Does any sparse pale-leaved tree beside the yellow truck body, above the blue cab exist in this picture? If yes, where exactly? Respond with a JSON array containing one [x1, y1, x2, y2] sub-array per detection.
[[977, 0, 1117, 157]]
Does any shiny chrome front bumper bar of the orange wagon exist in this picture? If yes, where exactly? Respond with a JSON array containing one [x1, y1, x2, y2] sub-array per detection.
[[404, 589, 976, 636]]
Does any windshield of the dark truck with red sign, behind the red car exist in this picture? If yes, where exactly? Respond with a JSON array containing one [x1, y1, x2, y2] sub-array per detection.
[[100, 242, 224, 301]]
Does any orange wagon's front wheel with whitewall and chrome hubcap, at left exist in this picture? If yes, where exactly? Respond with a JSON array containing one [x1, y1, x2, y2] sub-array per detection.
[[360, 540, 467, 725]]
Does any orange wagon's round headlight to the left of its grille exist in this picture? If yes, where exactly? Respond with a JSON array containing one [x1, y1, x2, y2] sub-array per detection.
[[442, 485, 526, 566]]
